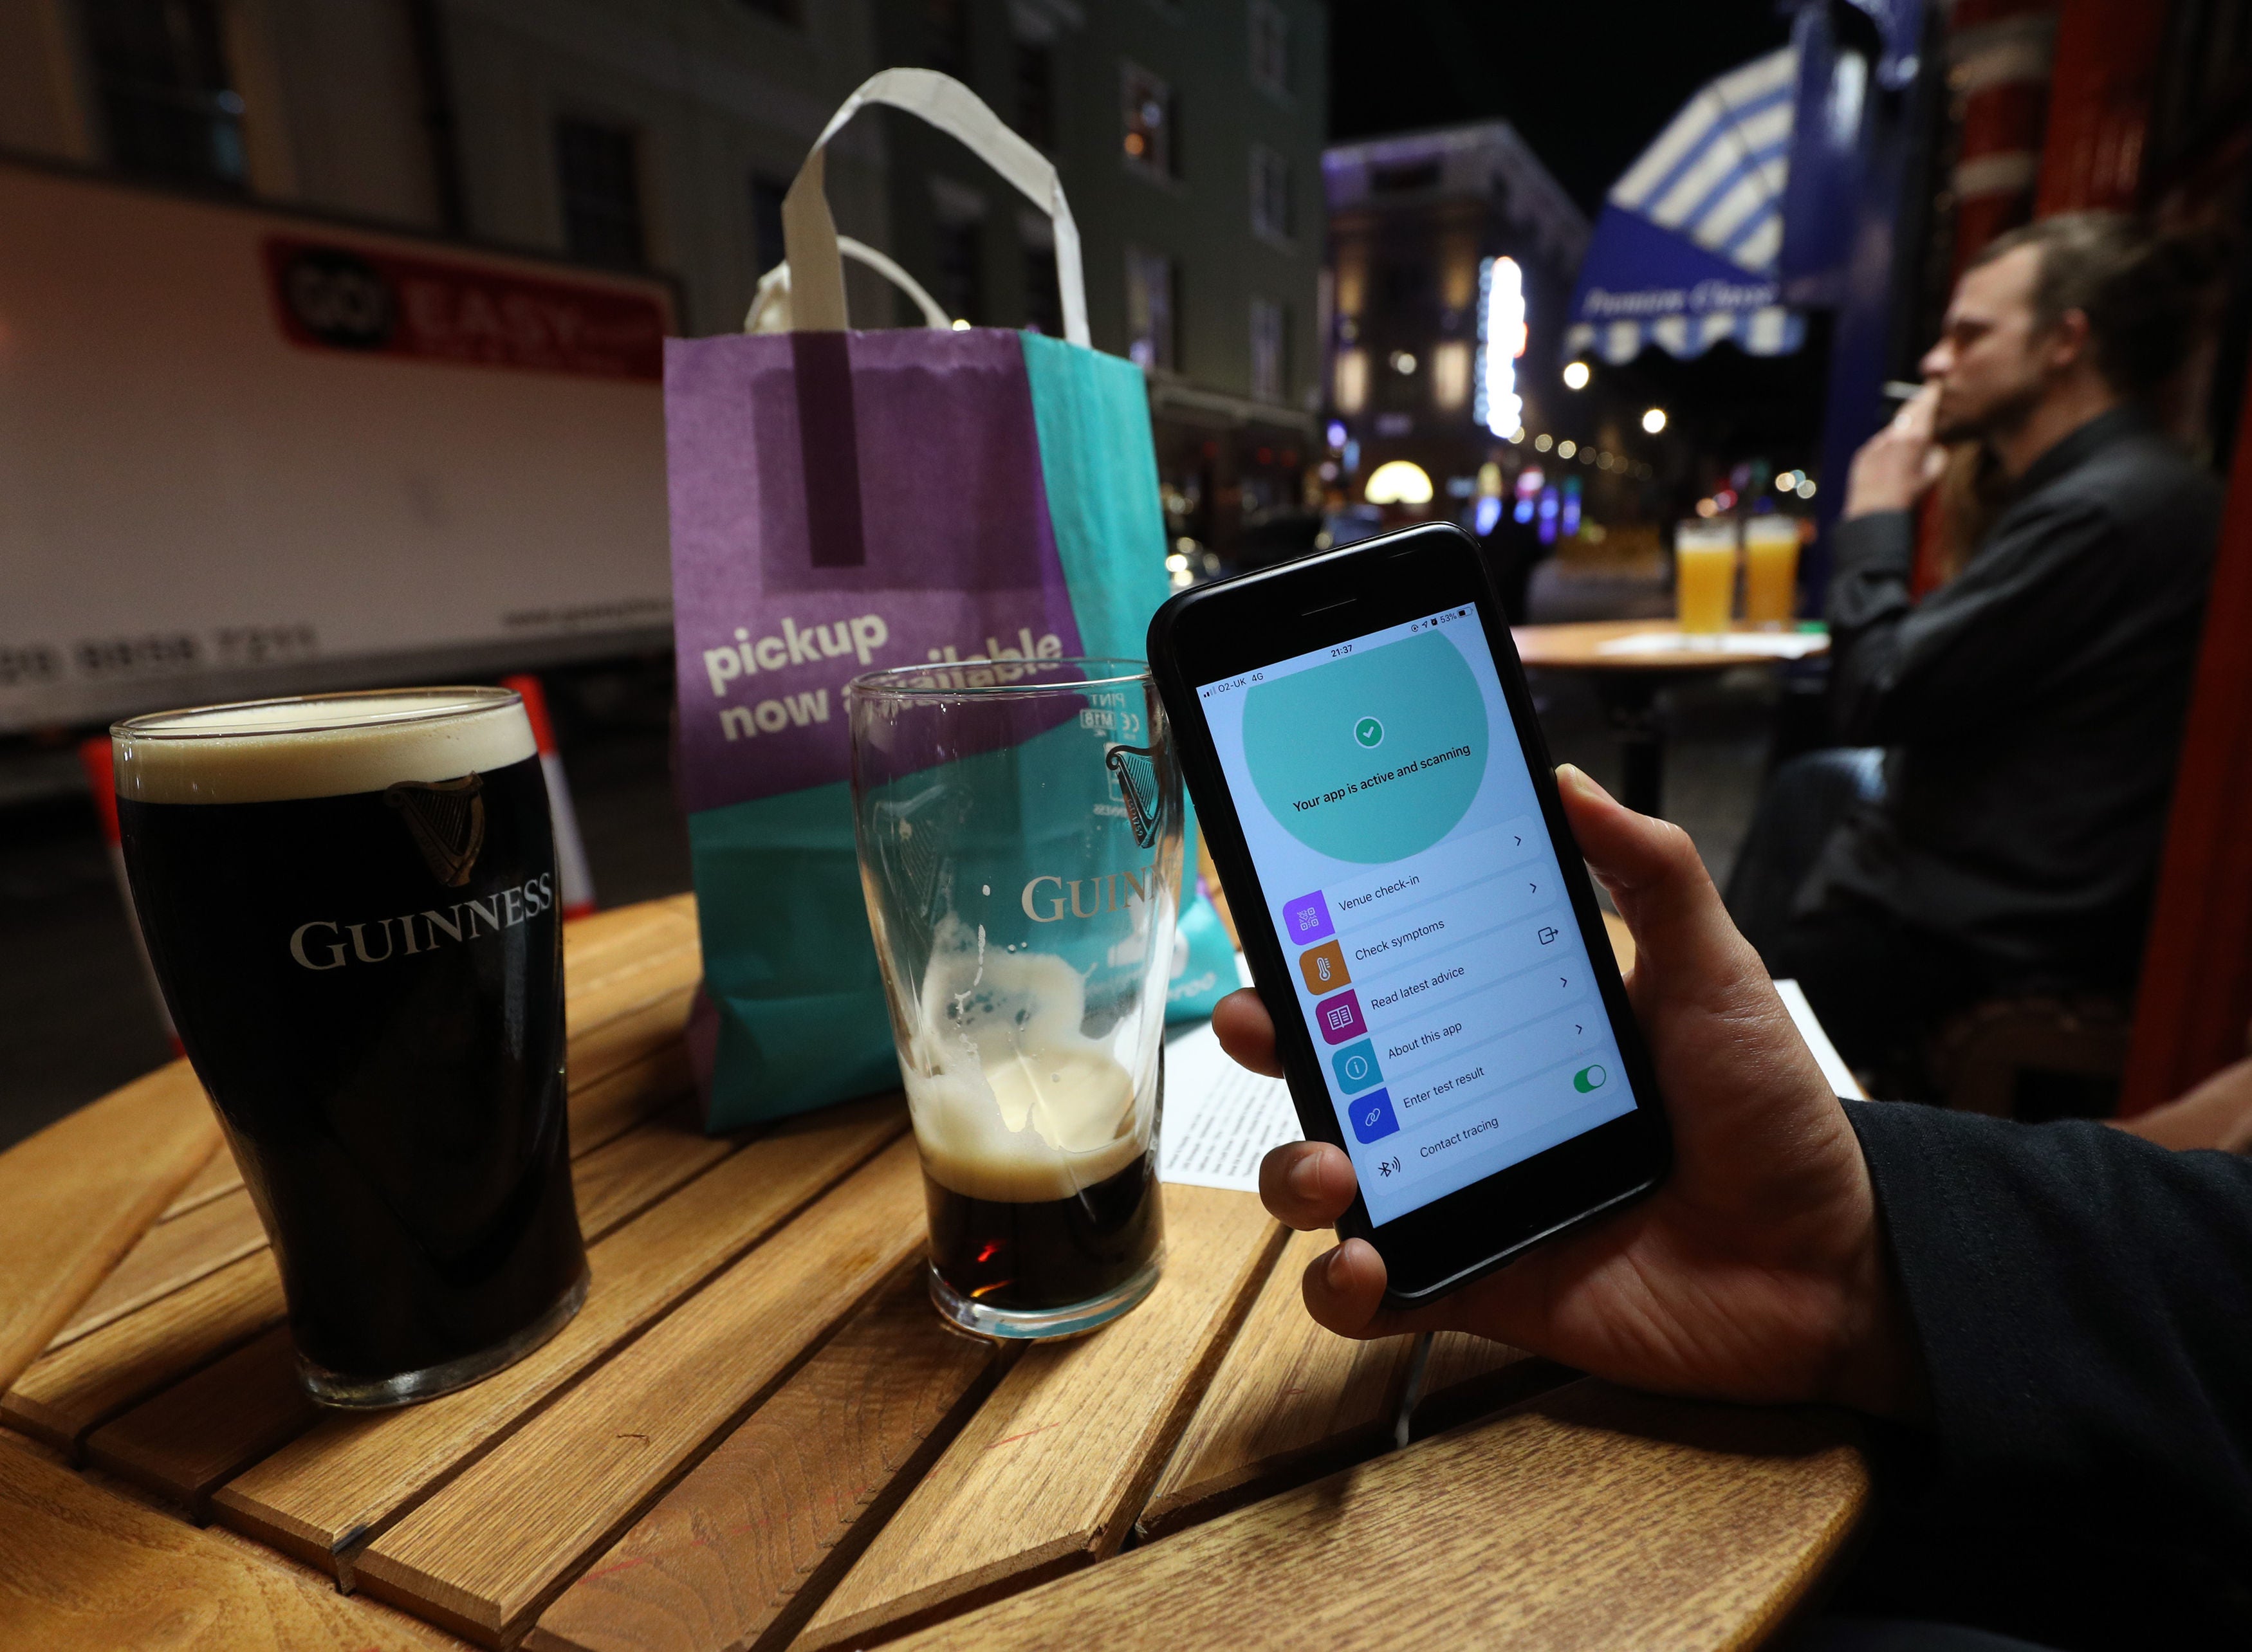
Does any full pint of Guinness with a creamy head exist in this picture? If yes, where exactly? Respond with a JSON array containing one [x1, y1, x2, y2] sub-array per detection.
[[111, 689, 588, 1407]]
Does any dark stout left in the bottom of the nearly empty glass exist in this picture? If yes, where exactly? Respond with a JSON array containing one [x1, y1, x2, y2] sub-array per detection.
[[923, 1152, 1165, 1312]]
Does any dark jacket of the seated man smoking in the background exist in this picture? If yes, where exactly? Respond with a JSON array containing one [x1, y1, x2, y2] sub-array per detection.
[[1800, 407, 2220, 986]]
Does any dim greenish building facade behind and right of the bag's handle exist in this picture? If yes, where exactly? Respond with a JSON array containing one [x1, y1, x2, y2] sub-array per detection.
[[876, 0, 1329, 554]]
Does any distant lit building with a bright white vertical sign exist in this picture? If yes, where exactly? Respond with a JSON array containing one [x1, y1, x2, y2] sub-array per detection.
[[1322, 122, 1608, 527]]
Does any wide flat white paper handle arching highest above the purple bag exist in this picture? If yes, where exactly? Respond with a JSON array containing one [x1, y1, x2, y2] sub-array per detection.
[[782, 69, 1093, 344]]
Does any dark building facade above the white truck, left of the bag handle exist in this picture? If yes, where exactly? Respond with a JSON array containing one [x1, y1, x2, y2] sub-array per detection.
[[0, 0, 890, 333]]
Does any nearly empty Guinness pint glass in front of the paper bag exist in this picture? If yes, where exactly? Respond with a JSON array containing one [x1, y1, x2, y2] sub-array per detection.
[[847, 659, 1180, 1337]]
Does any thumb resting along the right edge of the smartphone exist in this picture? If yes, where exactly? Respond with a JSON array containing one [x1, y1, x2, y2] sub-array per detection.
[[1556, 763, 1766, 997]]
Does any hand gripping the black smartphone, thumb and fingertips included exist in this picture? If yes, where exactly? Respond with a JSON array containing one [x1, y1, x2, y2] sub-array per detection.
[[1212, 770, 1926, 1418]]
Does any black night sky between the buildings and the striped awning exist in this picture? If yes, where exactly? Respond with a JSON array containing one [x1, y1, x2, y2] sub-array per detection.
[[1329, 0, 1791, 218]]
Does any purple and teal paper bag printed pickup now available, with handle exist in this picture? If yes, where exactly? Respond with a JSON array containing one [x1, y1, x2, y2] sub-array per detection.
[[665, 69, 1237, 1130]]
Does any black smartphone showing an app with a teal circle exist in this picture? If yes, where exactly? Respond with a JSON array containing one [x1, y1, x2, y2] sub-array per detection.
[[1149, 524, 1671, 1305]]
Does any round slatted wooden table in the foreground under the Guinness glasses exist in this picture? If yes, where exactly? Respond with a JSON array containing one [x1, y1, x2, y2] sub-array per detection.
[[0, 900, 1867, 1652]]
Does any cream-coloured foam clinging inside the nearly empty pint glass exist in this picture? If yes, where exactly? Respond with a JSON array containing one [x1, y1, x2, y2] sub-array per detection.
[[905, 918, 1151, 1204]]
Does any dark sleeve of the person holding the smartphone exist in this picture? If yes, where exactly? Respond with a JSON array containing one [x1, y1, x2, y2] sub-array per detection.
[[1838, 1103, 2252, 1647]]
